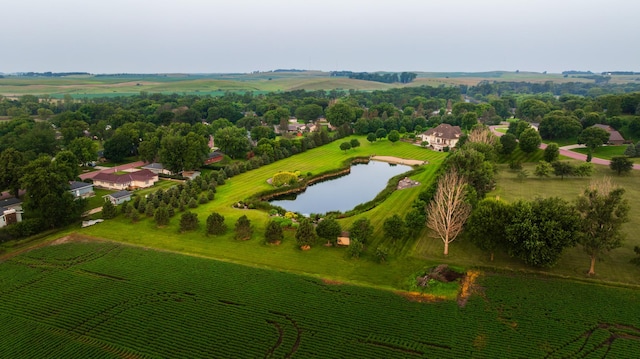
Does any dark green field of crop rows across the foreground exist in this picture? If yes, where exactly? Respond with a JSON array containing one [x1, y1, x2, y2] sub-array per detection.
[[0, 242, 640, 358]]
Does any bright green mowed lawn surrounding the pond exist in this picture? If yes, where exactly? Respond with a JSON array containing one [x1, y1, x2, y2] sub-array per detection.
[[79, 136, 446, 288]]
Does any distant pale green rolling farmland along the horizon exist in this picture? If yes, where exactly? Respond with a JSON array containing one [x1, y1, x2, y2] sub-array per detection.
[[0, 71, 637, 98]]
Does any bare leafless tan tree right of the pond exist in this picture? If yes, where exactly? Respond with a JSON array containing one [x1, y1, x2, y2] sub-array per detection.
[[427, 170, 471, 256]]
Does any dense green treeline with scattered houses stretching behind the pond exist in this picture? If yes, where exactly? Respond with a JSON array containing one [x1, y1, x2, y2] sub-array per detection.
[[0, 83, 640, 246]]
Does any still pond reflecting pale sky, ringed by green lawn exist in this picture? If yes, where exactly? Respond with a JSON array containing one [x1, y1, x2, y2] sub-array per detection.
[[271, 161, 411, 216]]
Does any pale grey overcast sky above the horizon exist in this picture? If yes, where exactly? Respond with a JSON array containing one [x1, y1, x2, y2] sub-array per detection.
[[0, 0, 640, 73]]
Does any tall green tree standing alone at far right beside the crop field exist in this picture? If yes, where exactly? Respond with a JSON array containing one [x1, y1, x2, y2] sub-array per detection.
[[576, 177, 629, 275]]
